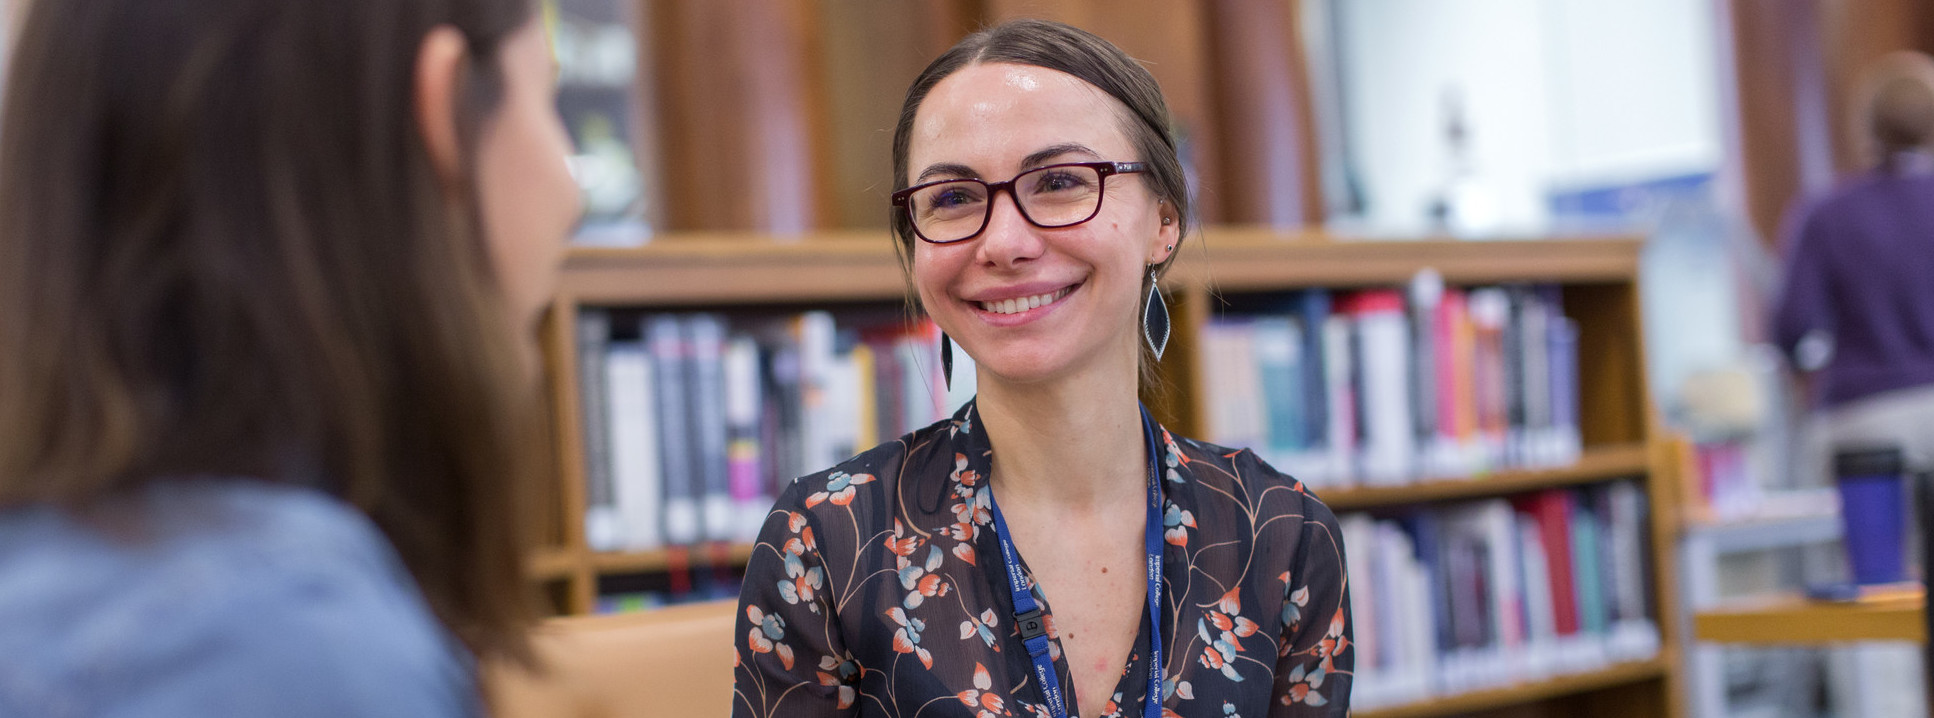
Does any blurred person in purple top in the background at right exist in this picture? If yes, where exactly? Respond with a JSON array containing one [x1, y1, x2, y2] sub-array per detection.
[[1773, 52, 1934, 472]]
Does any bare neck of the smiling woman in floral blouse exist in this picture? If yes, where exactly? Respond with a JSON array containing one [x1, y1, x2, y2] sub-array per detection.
[[977, 358, 1147, 509]]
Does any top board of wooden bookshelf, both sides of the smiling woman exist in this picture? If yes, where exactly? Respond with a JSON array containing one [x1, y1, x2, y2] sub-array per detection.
[[563, 226, 1638, 306]]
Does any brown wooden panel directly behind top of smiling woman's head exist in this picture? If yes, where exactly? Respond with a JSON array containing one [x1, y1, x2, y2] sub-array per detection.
[[986, 0, 1228, 223]]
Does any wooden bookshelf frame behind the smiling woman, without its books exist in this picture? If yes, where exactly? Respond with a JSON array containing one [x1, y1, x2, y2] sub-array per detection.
[[532, 226, 1683, 718]]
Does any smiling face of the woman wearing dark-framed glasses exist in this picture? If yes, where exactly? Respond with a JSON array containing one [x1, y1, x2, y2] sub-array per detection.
[[907, 64, 1180, 383]]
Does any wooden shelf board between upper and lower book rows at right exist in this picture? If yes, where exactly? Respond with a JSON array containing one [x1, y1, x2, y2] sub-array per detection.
[[1317, 443, 1650, 511]]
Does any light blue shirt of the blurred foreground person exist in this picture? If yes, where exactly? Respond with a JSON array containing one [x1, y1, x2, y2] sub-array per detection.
[[0, 480, 482, 718]]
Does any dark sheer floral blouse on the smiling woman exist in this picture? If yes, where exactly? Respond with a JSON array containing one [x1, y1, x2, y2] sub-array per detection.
[[733, 403, 1356, 718]]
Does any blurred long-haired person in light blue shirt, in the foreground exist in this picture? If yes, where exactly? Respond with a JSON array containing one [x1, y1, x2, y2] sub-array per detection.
[[0, 0, 578, 718]]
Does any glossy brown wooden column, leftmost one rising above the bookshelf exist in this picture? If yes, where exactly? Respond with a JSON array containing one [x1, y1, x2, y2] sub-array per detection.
[[646, 0, 830, 234]]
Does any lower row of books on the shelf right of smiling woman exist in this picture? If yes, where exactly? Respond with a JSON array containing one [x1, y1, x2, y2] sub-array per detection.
[[1340, 482, 1659, 708]]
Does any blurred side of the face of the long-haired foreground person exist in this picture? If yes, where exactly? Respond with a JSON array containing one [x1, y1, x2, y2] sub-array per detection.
[[476, 19, 580, 334]]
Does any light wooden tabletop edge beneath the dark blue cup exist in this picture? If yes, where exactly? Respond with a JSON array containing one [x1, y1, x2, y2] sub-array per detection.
[[1692, 590, 1928, 644]]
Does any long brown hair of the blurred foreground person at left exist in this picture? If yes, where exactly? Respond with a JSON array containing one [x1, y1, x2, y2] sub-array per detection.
[[0, 0, 543, 658]]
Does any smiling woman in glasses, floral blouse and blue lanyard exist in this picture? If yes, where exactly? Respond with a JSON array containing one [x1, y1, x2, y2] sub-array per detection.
[[733, 21, 1354, 718]]
